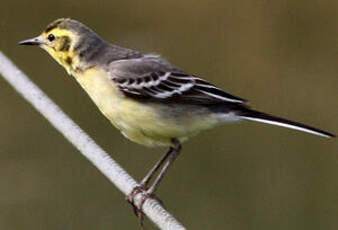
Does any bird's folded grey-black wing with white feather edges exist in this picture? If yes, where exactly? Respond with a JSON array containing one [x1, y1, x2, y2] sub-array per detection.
[[108, 56, 246, 104]]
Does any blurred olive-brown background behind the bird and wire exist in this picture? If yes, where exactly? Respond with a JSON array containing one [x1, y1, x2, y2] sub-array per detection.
[[0, 0, 338, 230]]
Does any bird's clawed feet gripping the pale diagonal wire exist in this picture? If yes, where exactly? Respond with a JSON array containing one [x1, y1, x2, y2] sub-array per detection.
[[126, 185, 164, 226]]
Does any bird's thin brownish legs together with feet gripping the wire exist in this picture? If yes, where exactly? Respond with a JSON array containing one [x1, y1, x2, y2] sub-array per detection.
[[127, 139, 182, 225]]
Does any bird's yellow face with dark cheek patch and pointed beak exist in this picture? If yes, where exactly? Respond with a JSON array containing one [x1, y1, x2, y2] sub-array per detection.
[[20, 27, 79, 74]]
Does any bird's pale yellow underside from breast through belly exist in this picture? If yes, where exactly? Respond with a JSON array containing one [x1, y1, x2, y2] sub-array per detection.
[[74, 68, 218, 146]]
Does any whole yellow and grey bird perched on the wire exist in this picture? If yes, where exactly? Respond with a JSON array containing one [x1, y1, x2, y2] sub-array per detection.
[[19, 18, 335, 223]]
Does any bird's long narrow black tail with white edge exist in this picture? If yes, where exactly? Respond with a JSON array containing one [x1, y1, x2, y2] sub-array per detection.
[[238, 109, 335, 138]]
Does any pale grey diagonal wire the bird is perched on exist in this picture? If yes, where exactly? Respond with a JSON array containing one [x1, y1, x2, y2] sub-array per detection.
[[0, 51, 185, 230]]
